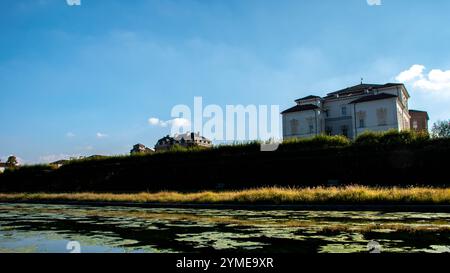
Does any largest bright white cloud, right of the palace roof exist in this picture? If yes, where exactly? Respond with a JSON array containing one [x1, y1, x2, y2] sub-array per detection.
[[395, 64, 450, 96]]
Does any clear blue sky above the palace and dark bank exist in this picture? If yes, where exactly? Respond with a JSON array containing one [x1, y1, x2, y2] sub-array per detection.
[[0, 0, 450, 164]]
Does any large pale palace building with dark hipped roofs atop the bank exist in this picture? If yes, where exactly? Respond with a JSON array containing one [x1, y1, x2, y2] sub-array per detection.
[[281, 83, 428, 139]]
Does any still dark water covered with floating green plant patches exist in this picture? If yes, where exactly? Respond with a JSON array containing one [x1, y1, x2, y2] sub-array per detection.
[[0, 204, 450, 253]]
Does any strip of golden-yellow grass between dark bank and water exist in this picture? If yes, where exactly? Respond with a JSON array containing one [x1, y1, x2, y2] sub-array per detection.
[[0, 186, 450, 204]]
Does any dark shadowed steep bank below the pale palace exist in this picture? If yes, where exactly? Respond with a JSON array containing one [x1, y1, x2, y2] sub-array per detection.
[[0, 132, 450, 192]]
